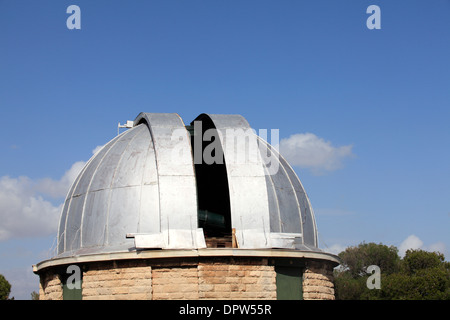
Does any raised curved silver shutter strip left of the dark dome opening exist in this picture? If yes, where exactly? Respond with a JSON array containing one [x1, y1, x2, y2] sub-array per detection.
[[135, 113, 197, 248]]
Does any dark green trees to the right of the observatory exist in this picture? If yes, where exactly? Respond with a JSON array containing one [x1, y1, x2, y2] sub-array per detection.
[[335, 243, 450, 300]]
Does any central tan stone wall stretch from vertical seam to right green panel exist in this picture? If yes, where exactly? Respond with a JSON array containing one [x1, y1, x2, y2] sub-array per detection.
[[152, 259, 276, 300]]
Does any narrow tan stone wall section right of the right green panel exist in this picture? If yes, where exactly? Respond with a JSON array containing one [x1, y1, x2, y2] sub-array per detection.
[[303, 261, 334, 300]]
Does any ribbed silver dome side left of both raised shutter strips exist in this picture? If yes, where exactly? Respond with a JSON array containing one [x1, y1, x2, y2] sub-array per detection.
[[58, 125, 159, 254]]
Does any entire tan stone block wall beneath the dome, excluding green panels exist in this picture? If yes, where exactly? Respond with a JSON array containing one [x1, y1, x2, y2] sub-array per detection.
[[40, 257, 334, 300]]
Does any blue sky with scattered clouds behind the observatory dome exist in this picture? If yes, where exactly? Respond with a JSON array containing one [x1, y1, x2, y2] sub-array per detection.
[[0, 0, 450, 299]]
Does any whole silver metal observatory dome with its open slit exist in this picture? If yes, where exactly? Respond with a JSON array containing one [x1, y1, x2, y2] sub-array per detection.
[[57, 113, 321, 257]]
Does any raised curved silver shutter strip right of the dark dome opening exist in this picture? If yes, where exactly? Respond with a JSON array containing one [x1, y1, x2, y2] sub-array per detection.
[[197, 114, 271, 248]]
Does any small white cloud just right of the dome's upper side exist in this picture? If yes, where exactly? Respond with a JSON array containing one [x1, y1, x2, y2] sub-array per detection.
[[279, 133, 354, 174]]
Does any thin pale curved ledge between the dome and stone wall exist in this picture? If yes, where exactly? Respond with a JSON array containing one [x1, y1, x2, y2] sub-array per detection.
[[33, 248, 340, 274]]
